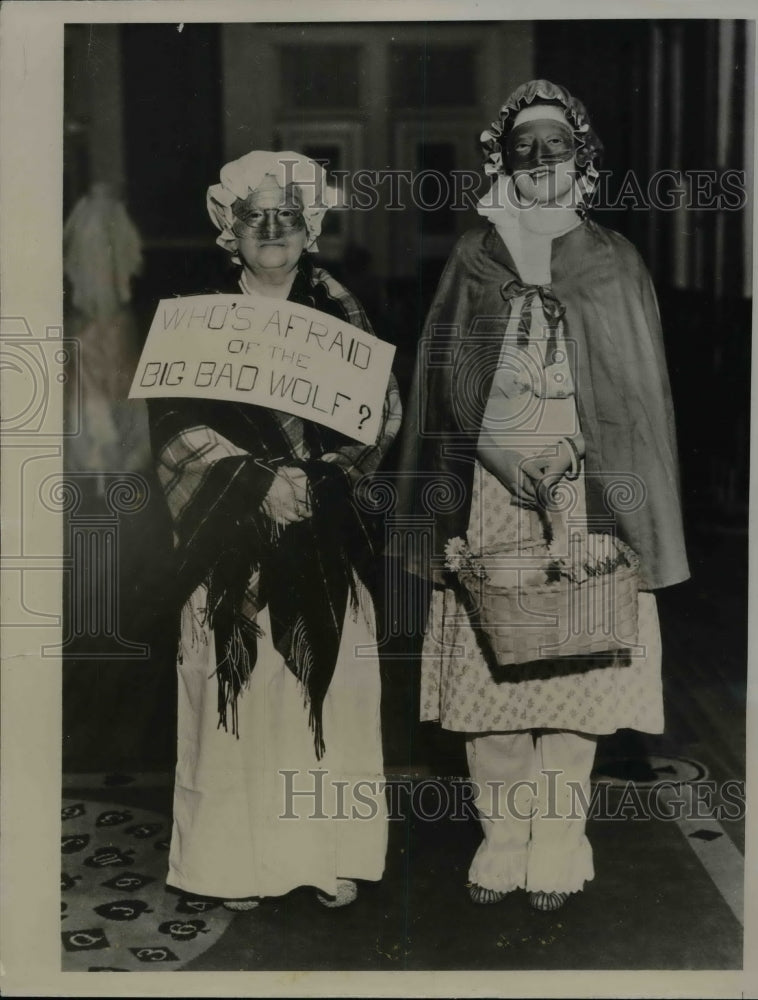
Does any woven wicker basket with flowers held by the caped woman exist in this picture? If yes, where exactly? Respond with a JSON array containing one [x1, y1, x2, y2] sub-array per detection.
[[459, 538, 639, 666]]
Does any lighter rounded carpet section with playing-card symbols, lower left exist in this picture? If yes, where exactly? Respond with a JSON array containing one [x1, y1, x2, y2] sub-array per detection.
[[61, 798, 234, 972]]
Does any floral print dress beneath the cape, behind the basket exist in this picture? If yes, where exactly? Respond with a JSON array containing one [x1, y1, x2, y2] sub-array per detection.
[[421, 296, 663, 735]]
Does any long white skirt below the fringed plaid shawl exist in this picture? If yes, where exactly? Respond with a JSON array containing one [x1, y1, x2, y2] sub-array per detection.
[[168, 589, 387, 898]]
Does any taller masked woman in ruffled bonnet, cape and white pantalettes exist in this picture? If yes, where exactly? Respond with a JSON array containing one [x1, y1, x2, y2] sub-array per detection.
[[403, 80, 688, 911]]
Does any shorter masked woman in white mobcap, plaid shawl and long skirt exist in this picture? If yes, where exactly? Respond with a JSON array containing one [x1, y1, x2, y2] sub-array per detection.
[[150, 151, 401, 910]]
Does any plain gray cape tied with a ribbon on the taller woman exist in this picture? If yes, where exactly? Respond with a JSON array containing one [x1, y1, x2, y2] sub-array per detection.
[[398, 221, 689, 590]]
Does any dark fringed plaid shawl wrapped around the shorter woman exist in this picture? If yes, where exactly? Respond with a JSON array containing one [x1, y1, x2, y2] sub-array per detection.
[[149, 256, 401, 758]]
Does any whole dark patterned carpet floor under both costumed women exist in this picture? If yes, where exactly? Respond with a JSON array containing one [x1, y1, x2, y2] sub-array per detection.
[[61, 760, 742, 972]]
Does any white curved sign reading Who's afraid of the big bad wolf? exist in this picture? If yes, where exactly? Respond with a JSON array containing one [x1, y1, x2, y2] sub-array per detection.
[[129, 294, 395, 444]]
